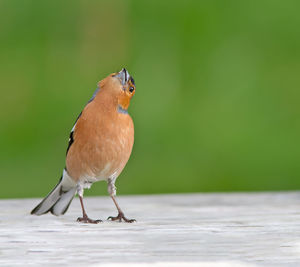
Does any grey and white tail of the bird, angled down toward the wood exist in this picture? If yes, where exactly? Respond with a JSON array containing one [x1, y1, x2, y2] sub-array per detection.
[[31, 170, 76, 216]]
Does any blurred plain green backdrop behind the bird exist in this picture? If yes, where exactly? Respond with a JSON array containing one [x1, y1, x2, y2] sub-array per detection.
[[0, 0, 300, 198]]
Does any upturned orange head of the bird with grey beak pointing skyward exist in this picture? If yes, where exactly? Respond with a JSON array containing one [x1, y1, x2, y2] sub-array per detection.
[[100, 68, 135, 110]]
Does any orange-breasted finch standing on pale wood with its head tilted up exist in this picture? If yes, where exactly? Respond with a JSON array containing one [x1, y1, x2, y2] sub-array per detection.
[[31, 68, 136, 224]]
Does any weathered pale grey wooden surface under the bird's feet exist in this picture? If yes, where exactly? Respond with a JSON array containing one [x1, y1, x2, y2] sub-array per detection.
[[0, 192, 300, 266]]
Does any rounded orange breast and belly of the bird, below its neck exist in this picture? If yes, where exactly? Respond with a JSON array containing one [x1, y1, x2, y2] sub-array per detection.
[[66, 97, 134, 181]]
